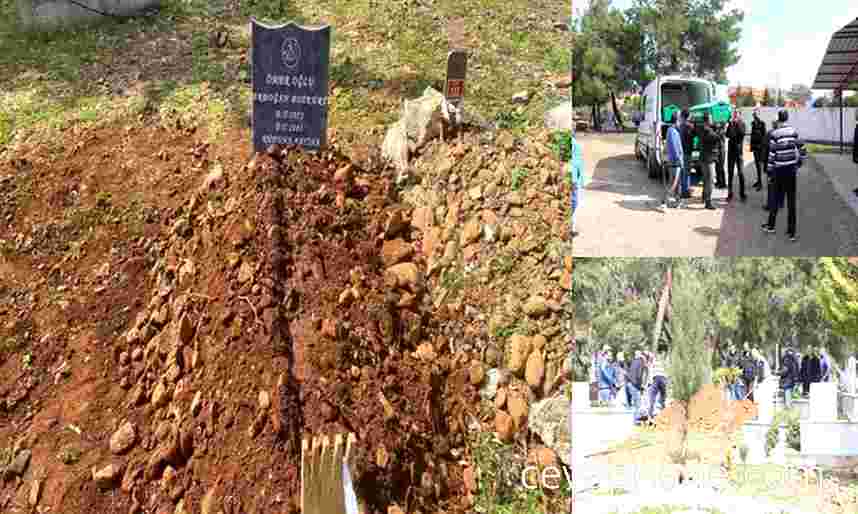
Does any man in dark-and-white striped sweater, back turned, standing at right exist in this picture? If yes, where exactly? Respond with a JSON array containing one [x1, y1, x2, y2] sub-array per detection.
[[763, 111, 807, 241]]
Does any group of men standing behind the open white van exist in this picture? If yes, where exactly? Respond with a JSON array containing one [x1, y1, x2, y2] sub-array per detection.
[[665, 109, 807, 241]]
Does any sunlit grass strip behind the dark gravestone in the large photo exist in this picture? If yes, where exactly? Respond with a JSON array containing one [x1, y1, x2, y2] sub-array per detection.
[[0, 0, 570, 151]]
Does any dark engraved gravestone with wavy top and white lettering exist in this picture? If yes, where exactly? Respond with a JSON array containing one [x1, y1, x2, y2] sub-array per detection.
[[250, 18, 331, 152]]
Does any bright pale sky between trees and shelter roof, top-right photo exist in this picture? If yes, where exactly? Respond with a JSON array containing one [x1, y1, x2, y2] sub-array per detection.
[[572, 0, 858, 96]]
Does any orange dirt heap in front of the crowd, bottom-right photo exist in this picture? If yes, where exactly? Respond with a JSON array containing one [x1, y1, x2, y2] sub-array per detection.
[[655, 384, 757, 433]]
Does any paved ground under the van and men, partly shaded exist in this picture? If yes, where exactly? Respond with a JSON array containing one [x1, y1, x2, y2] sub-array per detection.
[[573, 134, 858, 257]]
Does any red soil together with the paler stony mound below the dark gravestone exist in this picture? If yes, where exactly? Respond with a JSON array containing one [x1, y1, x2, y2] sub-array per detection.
[[0, 119, 571, 514]]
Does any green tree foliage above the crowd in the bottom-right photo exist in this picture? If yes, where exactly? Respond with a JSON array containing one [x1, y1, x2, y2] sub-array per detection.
[[571, 257, 858, 366]]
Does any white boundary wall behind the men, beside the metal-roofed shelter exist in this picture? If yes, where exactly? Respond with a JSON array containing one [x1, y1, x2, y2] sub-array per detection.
[[739, 107, 858, 144]]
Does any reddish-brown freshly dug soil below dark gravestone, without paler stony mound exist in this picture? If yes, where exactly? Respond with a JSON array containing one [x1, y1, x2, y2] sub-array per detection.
[[0, 125, 479, 514]]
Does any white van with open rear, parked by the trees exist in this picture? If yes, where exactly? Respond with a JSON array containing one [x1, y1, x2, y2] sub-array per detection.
[[635, 75, 729, 178]]
